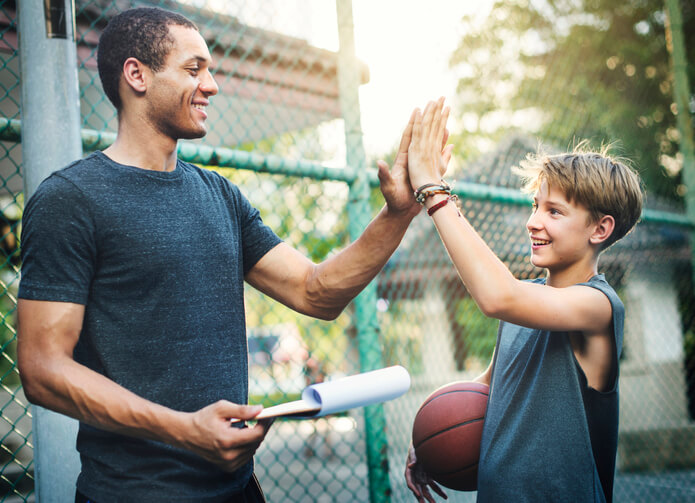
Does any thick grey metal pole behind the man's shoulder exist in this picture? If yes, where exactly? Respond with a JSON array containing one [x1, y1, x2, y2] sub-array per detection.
[[18, 0, 82, 503]]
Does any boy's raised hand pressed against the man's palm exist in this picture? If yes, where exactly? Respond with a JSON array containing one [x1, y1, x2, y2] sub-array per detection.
[[408, 98, 453, 190]]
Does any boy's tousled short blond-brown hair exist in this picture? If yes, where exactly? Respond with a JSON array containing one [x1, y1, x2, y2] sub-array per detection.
[[512, 141, 642, 250]]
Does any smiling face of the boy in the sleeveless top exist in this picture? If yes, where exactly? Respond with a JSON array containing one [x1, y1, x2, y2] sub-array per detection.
[[526, 181, 595, 272]]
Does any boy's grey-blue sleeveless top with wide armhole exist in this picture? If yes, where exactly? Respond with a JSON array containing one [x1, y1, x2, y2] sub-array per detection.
[[478, 275, 625, 503]]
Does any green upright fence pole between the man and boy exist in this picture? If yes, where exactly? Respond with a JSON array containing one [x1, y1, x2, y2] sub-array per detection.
[[336, 0, 391, 503]]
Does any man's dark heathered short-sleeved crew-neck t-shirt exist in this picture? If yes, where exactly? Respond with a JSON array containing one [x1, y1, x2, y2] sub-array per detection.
[[19, 152, 280, 503]]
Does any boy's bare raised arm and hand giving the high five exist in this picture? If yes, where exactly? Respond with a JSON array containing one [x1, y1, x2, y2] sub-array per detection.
[[408, 99, 612, 336]]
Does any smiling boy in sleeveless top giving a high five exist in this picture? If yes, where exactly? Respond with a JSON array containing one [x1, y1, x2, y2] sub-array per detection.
[[406, 99, 642, 503]]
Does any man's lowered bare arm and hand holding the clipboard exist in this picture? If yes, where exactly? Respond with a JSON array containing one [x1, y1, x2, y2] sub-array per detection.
[[17, 299, 270, 471]]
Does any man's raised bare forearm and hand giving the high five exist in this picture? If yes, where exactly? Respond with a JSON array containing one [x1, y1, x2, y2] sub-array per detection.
[[246, 114, 451, 319]]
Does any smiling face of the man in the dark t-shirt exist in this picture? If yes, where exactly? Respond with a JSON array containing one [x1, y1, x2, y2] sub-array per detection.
[[147, 25, 218, 140]]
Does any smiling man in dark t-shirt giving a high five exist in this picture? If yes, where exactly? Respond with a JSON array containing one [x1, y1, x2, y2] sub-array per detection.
[[18, 8, 420, 503]]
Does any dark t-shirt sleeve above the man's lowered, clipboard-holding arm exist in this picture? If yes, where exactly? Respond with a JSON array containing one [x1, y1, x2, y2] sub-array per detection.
[[19, 174, 97, 305]]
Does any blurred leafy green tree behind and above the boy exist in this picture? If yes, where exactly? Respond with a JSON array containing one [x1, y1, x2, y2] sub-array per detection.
[[451, 0, 695, 201]]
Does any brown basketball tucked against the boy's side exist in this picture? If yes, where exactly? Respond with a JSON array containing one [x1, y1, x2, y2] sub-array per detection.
[[413, 381, 489, 491]]
